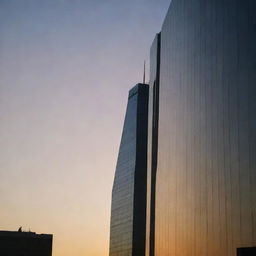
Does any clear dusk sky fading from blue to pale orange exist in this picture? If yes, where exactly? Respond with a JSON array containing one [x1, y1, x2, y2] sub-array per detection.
[[0, 0, 170, 256]]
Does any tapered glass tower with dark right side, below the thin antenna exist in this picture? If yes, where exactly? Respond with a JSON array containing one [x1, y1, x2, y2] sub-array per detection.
[[109, 84, 148, 256]]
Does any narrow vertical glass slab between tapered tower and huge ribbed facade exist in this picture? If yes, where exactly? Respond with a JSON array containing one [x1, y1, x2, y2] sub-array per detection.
[[146, 34, 161, 255]]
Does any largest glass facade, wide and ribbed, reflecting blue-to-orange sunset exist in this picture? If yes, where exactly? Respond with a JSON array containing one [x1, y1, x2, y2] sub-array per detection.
[[150, 0, 256, 256]]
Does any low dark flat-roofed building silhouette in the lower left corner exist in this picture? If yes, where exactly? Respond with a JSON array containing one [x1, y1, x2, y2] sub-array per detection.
[[0, 231, 52, 256]]
